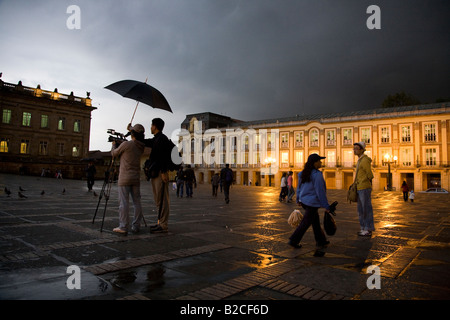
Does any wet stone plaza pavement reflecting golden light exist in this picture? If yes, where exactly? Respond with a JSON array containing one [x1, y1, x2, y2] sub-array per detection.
[[0, 174, 450, 301]]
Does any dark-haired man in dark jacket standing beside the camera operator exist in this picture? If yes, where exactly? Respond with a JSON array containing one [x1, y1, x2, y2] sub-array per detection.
[[145, 118, 170, 233]]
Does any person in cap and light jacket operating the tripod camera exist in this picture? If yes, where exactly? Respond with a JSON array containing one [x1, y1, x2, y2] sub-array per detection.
[[111, 124, 145, 235]]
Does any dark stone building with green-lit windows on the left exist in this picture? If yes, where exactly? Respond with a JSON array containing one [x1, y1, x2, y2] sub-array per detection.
[[0, 79, 96, 178]]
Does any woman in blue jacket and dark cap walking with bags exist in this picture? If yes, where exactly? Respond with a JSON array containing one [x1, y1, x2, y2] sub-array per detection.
[[289, 153, 330, 248]]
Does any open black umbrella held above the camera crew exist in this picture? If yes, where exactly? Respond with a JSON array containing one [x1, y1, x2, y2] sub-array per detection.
[[105, 80, 172, 122]]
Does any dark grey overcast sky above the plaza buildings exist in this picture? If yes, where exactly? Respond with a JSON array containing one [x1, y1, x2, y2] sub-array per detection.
[[0, 0, 450, 151]]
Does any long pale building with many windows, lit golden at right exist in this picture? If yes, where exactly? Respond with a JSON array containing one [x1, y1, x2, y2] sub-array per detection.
[[179, 102, 450, 192]]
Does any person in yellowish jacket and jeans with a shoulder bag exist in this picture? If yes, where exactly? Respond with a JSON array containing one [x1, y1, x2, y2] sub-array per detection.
[[353, 141, 375, 237]]
